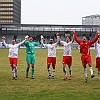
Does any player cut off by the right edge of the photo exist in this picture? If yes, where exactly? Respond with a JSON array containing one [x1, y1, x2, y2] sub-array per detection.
[[95, 35, 100, 81]]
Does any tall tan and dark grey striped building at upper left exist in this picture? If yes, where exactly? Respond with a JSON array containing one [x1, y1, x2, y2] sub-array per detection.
[[0, 0, 21, 24]]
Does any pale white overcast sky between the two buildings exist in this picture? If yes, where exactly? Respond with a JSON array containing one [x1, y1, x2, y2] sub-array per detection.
[[21, 0, 100, 25]]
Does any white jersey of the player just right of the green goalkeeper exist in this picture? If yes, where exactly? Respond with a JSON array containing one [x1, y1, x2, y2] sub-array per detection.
[[43, 43, 58, 57]]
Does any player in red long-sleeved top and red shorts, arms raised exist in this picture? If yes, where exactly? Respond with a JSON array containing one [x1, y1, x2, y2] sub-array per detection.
[[73, 31, 100, 82]]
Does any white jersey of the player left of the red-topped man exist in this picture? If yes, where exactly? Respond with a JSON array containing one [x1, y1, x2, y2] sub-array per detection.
[[60, 41, 73, 56]]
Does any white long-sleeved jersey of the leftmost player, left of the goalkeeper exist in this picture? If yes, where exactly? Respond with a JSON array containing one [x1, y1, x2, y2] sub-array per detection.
[[3, 40, 25, 58]]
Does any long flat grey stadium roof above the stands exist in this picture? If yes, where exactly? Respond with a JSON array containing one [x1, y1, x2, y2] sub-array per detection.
[[0, 24, 100, 29]]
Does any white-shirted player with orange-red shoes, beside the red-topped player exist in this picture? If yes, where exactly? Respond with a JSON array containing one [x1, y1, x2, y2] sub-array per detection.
[[60, 33, 74, 80]]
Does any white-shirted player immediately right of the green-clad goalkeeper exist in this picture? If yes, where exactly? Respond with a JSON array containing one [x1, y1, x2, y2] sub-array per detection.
[[41, 36, 58, 79]]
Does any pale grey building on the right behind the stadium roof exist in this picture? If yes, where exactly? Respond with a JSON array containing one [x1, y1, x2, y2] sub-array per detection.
[[82, 14, 100, 25]]
